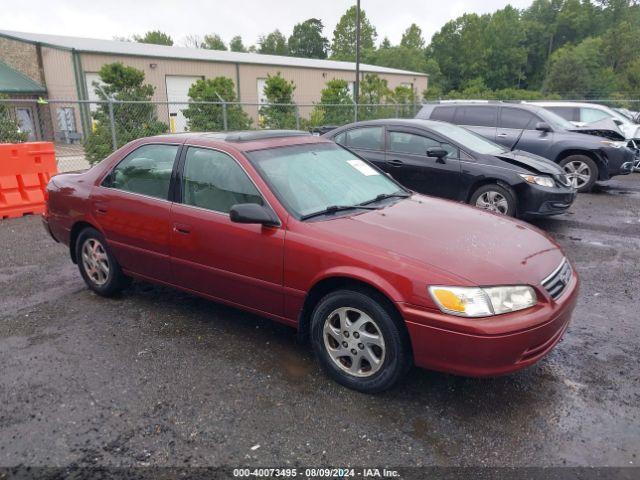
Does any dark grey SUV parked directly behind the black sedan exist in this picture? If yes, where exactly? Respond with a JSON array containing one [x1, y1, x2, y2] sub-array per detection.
[[416, 102, 634, 192]]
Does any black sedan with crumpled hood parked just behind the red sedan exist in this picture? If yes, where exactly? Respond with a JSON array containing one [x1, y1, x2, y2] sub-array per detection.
[[324, 119, 576, 217]]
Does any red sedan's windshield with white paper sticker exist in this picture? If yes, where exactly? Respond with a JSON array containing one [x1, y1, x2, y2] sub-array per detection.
[[248, 143, 404, 217]]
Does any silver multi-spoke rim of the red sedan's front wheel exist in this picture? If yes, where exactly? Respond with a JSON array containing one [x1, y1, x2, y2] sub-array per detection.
[[323, 307, 386, 377]]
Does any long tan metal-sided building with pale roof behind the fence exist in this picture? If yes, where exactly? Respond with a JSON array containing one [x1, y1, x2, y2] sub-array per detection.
[[0, 30, 428, 136]]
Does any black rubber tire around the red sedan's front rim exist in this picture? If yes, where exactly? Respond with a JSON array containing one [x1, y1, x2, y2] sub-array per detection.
[[311, 290, 413, 393]]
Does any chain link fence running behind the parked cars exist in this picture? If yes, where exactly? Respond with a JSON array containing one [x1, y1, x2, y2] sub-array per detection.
[[0, 99, 640, 172]]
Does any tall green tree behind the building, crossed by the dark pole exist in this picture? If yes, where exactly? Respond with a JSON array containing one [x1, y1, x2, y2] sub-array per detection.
[[331, 6, 378, 61]]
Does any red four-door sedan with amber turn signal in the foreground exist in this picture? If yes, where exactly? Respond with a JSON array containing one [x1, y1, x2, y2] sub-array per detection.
[[44, 131, 578, 392]]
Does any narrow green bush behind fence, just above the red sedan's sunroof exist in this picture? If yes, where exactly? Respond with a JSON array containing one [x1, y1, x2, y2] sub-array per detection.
[[260, 72, 296, 129]]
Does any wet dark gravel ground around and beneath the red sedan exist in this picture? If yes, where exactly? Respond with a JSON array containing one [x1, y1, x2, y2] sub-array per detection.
[[0, 174, 640, 466]]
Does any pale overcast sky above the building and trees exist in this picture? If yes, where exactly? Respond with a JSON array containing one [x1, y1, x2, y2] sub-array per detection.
[[0, 0, 532, 46]]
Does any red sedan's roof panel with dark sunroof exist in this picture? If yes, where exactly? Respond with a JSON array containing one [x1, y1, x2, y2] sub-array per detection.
[[150, 130, 332, 152]]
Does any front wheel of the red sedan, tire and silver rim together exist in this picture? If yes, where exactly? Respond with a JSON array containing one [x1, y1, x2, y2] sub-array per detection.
[[311, 290, 411, 393]]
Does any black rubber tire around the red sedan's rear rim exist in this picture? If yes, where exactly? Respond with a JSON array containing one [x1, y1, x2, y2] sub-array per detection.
[[75, 227, 131, 297]]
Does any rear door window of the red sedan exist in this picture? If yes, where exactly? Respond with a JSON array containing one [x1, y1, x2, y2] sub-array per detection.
[[102, 144, 178, 200]]
